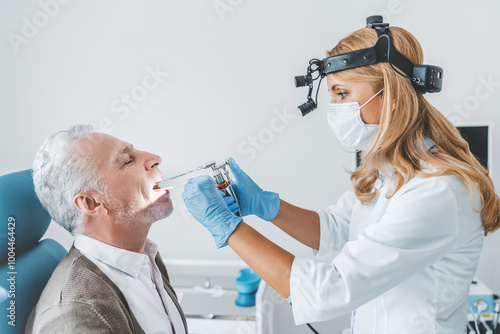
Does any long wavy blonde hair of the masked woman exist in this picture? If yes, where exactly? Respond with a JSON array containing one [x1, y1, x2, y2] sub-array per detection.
[[327, 27, 500, 235]]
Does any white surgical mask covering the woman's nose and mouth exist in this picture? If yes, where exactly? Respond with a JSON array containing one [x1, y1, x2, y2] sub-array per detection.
[[327, 88, 384, 151]]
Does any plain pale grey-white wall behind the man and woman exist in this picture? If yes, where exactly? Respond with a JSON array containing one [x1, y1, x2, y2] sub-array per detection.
[[0, 0, 500, 332]]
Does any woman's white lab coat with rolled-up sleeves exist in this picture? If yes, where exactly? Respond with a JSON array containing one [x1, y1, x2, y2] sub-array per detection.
[[290, 170, 484, 334]]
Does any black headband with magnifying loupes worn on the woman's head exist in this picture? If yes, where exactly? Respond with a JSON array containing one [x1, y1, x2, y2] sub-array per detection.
[[295, 15, 443, 116]]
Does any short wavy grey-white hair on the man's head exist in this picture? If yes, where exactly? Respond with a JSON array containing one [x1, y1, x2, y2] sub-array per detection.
[[32, 125, 108, 233]]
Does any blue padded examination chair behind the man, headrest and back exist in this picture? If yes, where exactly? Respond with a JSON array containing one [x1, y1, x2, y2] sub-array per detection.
[[0, 169, 67, 334]]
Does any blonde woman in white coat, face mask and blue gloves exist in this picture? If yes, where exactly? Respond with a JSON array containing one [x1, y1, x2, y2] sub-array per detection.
[[183, 20, 500, 334]]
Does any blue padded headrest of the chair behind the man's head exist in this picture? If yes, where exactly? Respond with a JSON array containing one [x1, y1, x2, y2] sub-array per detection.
[[0, 169, 51, 263]]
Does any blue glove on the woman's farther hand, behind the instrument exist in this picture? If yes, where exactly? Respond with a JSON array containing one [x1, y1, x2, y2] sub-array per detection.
[[229, 158, 280, 221]]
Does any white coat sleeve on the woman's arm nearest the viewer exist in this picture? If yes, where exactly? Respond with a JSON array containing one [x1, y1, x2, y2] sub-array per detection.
[[290, 178, 458, 325]]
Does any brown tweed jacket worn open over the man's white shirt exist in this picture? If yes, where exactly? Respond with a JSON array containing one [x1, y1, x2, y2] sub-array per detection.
[[25, 246, 188, 334]]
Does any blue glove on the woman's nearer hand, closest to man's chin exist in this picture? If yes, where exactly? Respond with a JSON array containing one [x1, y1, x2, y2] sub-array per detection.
[[182, 175, 243, 248]]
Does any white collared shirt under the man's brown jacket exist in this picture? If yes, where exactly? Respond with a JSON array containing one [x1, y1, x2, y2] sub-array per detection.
[[75, 234, 185, 334]]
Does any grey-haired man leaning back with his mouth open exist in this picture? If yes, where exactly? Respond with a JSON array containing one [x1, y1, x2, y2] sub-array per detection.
[[26, 125, 187, 334]]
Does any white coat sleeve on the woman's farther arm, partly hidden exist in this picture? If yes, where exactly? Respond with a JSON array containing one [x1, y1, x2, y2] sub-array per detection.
[[315, 191, 356, 256]]
